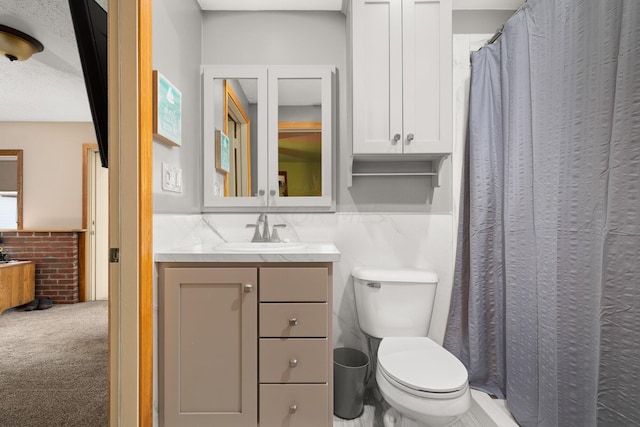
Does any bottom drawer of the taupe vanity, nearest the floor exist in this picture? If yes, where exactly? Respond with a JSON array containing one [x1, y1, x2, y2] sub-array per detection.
[[259, 384, 331, 427]]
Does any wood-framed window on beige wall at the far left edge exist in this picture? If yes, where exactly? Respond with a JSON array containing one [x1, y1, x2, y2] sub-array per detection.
[[0, 150, 22, 230]]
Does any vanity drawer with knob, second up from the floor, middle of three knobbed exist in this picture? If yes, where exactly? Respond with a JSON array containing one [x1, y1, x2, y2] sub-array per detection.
[[260, 338, 329, 383]]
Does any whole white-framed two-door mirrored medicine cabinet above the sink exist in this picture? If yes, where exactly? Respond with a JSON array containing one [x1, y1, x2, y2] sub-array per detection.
[[203, 66, 335, 211]]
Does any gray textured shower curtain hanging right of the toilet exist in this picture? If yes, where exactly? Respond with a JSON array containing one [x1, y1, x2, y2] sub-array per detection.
[[445, 0, 640, 427]]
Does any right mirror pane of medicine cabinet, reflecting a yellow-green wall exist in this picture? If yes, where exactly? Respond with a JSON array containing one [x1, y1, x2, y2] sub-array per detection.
[[278, 78, 322, 197]]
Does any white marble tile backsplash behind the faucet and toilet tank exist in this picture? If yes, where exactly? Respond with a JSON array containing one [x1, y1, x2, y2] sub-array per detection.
[[153, 213, 454, 351]]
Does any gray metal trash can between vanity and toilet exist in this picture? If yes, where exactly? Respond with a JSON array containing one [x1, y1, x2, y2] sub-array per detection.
[[333, 348, 369, 420]]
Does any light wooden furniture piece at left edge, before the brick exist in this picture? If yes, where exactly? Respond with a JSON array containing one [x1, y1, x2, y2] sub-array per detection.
[[0, 261, 36, 314]]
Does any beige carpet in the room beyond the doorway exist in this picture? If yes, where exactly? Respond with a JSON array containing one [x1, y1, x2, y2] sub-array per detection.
[[0, 301, 108, 427]]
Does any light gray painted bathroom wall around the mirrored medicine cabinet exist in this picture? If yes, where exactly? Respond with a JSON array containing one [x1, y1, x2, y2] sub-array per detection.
[[153, 9, 506, 214]]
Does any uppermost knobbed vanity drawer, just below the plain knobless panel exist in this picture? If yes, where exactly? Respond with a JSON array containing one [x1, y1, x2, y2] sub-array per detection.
[[259, 302, 329, 337]]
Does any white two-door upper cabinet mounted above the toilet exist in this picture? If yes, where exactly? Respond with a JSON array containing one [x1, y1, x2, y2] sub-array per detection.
[[350, 0, 452, 156]]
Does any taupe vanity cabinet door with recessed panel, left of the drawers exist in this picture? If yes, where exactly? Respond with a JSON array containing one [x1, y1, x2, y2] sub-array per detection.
[[159, 268, 258, 427]]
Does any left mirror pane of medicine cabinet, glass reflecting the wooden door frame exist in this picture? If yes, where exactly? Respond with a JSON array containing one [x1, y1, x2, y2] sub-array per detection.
[[214, 79, 258, 197]]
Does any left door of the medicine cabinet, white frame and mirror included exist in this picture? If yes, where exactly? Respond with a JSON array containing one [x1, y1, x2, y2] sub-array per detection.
[[203, 67, 267, 207]]
